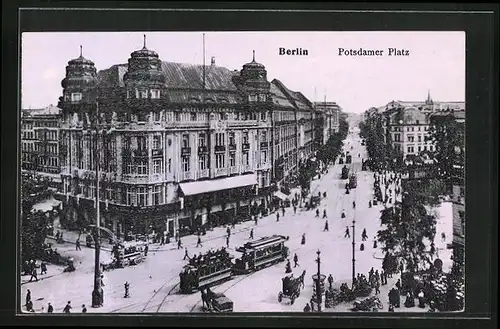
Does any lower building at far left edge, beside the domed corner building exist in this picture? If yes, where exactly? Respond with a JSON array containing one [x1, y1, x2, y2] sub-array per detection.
[[21, 105, 62, 188]]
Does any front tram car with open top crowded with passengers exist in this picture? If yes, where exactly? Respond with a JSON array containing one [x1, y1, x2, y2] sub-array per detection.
[[179, 249, 233, 294]]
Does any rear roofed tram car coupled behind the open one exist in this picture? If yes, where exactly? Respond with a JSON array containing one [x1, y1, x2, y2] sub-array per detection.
[[234, 235, 288, 274]]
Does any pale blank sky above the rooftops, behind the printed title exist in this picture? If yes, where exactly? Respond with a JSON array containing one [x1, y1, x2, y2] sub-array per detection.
[[21, 31, 465, 113]]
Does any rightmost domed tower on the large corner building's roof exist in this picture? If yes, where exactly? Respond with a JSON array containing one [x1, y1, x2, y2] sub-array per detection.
[[234, 50, 271, 102]]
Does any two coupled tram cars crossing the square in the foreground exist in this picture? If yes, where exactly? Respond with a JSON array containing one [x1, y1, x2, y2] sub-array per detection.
[[179, 235, 288, 294]]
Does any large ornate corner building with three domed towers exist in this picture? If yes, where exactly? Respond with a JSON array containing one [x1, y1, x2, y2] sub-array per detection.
[[54, 45, 332, 235]]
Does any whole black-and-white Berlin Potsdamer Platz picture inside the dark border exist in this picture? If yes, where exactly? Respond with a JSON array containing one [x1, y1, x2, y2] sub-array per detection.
[[16, 30, 467, 316]]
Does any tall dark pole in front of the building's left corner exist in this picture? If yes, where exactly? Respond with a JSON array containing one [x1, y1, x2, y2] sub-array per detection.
[[92, 102, 104, 307]]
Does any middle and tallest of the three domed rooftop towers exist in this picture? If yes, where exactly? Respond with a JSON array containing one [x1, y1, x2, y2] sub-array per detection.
[[123, 35, 165, 99]]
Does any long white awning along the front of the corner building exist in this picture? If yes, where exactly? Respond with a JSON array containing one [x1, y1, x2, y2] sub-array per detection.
[[179, 174, 257, 196]]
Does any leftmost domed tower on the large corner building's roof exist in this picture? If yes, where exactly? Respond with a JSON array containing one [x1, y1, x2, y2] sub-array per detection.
[[58, 46, 97, 111]]
